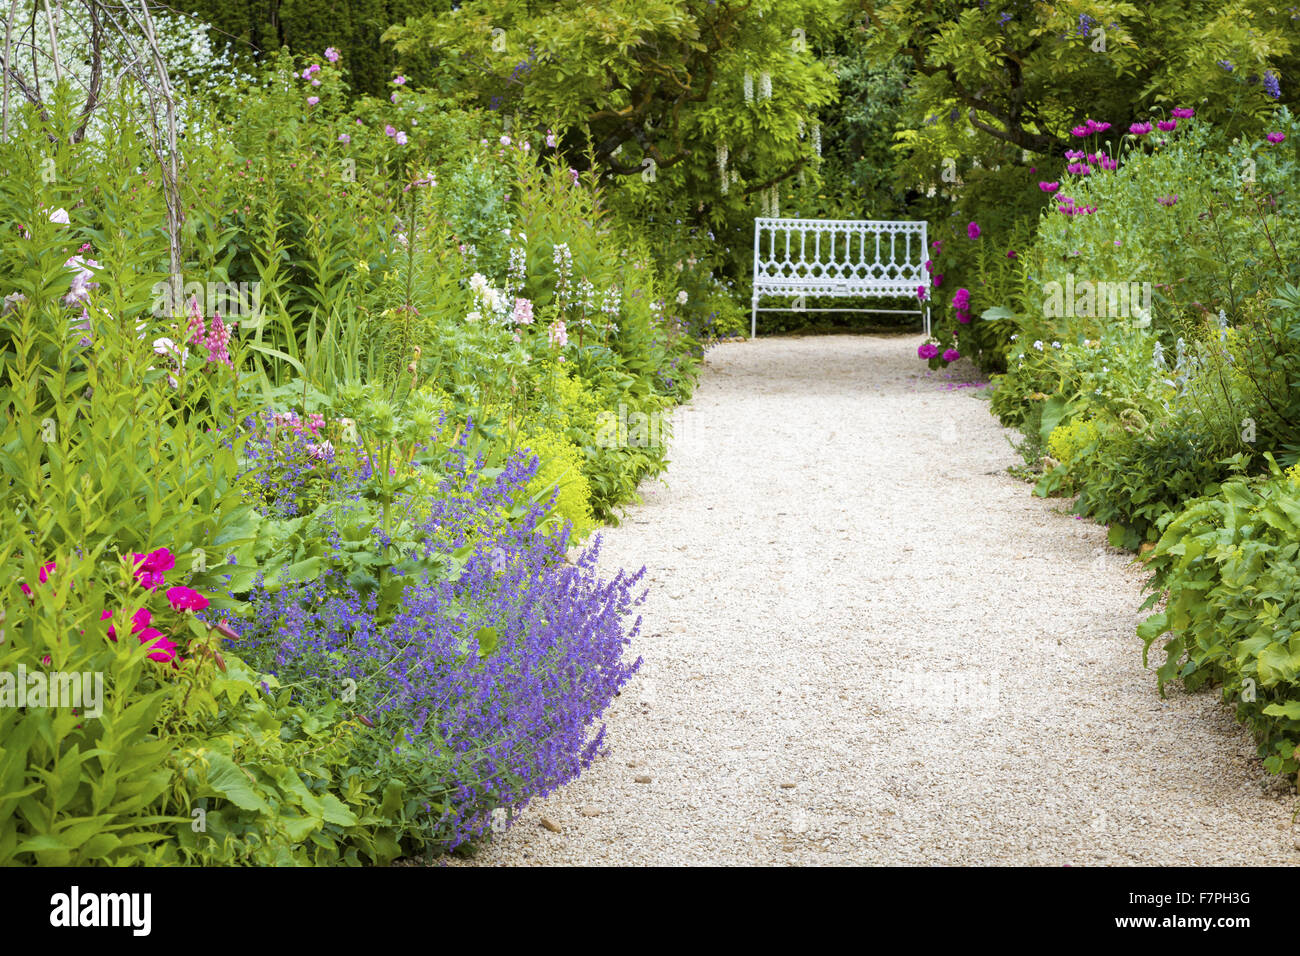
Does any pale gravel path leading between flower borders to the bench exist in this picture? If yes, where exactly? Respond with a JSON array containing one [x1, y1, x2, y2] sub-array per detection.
[[458, 336, 1300, 865]]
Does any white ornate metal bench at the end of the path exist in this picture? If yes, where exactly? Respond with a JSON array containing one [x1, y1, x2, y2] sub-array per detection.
[[749, 219, 931, 338]]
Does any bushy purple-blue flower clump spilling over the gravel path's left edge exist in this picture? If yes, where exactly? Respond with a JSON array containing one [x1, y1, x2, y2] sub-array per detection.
[[241, 442, 645, 849]]
